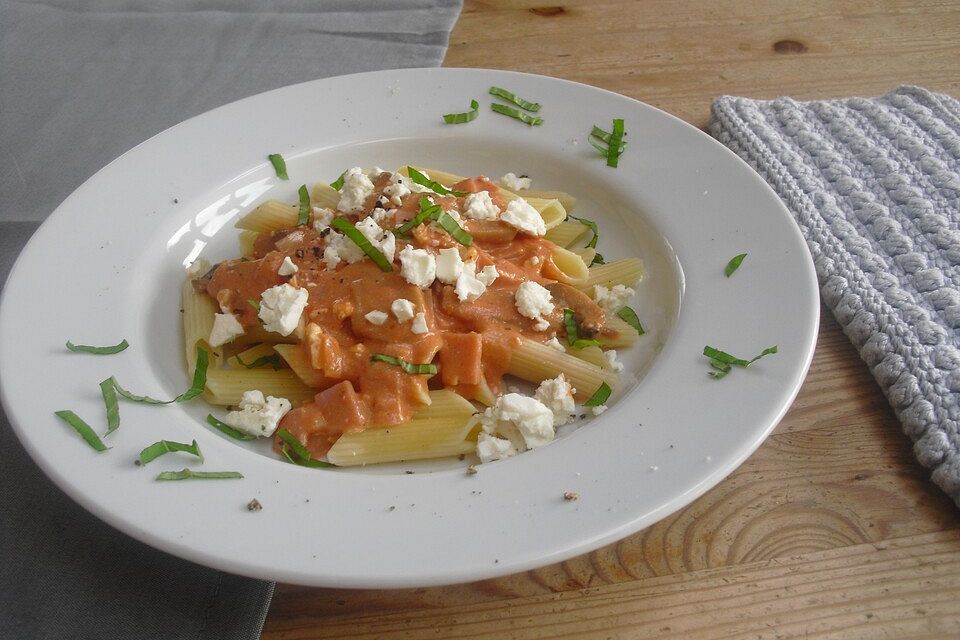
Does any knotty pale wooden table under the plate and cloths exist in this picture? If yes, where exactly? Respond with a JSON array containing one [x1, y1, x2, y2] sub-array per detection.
[[263, 0, 960, 640]]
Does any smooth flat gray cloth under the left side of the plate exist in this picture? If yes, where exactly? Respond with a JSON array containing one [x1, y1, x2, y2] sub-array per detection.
[[0, 0, 460, 640]]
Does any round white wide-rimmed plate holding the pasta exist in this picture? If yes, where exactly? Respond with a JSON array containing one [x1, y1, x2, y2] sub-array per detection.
[[0, 69, 818, 587]]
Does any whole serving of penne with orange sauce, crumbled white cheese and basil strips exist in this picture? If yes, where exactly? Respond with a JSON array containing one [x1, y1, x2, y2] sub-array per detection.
[[183, 167, 643, 466]]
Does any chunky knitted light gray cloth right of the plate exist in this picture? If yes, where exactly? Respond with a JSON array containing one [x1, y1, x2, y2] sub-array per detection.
[[711, 87, 960, 505]]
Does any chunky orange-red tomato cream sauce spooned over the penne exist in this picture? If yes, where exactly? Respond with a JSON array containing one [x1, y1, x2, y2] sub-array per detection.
[[198, 173, 603, 456]]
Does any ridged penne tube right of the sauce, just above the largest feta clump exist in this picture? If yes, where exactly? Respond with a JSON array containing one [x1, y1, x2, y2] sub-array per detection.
[[507, 338, 617, 401]]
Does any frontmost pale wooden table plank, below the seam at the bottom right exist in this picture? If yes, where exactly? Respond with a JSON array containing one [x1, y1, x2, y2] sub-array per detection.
[[264, 531, 960, 640]]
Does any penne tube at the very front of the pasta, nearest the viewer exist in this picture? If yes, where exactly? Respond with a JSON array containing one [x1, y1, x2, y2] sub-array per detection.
[[327, 390, 476, 467]]
